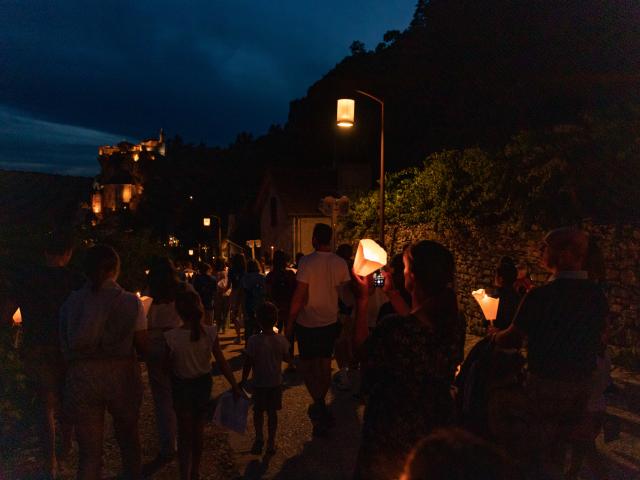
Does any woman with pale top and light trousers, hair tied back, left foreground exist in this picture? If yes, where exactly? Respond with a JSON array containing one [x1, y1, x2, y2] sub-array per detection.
[[60, 245, 146, 480]]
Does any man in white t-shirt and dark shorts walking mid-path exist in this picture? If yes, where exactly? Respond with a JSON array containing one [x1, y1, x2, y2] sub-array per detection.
[[286, 223, 351, 435]]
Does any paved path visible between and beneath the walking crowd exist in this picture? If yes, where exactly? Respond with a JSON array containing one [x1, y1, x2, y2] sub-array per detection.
[[5, 335, 640, 480]]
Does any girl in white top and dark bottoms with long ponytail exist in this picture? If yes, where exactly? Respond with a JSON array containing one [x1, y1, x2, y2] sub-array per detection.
[[164, 291, 243, 480]]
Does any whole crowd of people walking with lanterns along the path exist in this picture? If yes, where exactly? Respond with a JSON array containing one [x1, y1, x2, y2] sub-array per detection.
[[6, 224, 610, 480]]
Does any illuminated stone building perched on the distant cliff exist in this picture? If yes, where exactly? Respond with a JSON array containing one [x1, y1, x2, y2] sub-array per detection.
[[91, 129, 166, 220]]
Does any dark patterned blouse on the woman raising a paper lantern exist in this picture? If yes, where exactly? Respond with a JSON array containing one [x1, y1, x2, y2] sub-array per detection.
[[356, 315, 464, 479]]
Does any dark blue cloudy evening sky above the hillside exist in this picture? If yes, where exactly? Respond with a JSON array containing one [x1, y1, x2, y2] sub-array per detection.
[[0, 0, 415, 175]]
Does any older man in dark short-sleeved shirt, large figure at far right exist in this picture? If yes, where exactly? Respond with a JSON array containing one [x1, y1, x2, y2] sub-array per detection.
[[495, 228, 607, 478]]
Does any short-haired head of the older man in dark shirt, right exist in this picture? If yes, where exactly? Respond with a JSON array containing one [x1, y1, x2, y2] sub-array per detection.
[[540, 227, 589, 273]]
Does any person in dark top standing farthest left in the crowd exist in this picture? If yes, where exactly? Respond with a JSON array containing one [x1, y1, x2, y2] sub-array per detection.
[[10, 232, 85, 477]]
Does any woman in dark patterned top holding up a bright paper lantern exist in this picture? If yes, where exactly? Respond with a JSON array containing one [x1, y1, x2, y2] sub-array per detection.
[[355, 240, 464, 479]]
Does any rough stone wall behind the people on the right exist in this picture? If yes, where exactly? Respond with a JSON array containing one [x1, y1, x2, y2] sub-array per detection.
[[386, 223, 640, 369]]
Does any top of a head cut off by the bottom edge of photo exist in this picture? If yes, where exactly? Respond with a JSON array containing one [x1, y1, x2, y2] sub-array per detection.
[[400, 428, 508, 480]]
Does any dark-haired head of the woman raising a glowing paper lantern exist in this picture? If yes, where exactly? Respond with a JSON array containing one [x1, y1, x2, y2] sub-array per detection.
[[403, 240, 455, 297]]
